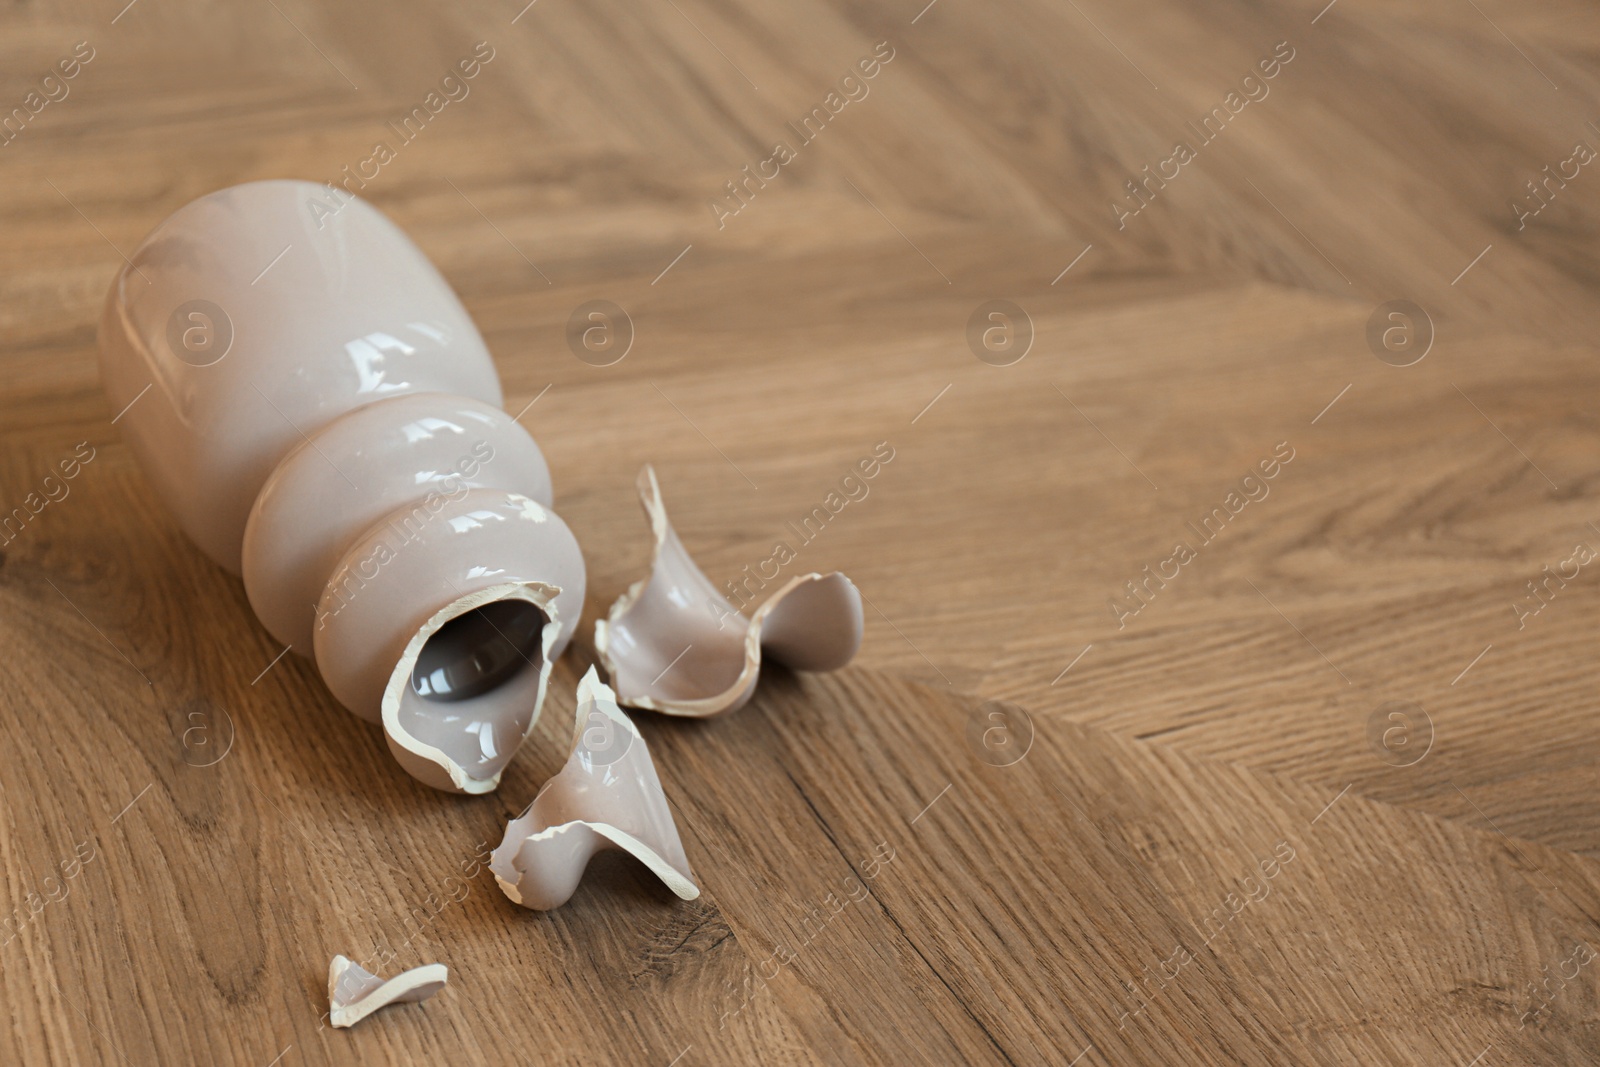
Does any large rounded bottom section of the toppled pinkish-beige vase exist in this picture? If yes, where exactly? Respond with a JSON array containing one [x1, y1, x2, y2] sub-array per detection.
[[99, 181, 501, 573]]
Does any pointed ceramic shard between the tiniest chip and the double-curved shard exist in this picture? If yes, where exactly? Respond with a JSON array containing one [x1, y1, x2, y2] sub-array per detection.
[[490, 667, 699, 912]]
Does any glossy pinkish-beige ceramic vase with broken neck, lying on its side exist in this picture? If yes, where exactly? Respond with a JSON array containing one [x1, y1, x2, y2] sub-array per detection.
[[99, 181, 584, 793]]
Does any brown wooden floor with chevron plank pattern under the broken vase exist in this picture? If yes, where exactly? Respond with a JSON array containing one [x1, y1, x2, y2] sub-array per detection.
[[0, 0, 1600, 1067]]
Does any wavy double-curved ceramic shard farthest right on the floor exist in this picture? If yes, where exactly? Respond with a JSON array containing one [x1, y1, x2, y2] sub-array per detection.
[[595, 464, 862, 717]]
